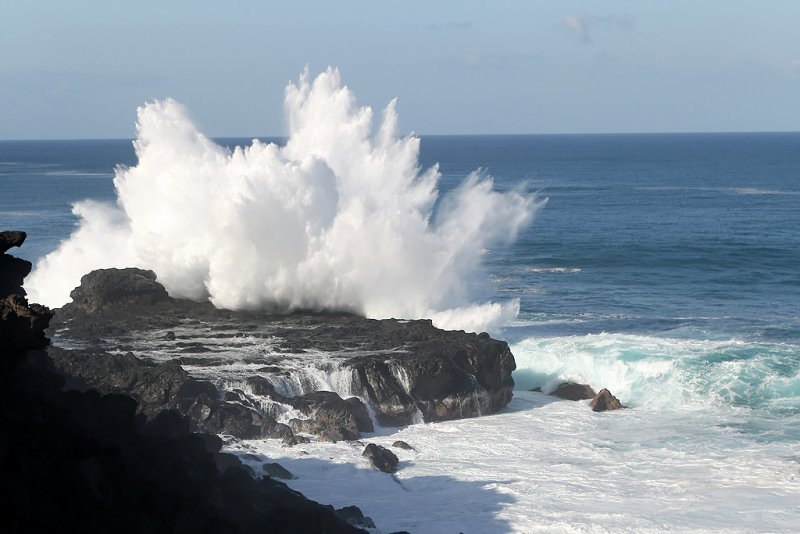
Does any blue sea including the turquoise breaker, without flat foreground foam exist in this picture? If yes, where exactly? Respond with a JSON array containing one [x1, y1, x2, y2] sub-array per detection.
[[0, 133, 800, 432]]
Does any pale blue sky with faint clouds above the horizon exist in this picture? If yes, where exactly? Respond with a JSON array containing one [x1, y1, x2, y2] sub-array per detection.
[[0, 0, 800, 139]]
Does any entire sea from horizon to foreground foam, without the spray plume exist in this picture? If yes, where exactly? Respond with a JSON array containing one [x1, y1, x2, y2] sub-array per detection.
[[0, 133, 800, 533]]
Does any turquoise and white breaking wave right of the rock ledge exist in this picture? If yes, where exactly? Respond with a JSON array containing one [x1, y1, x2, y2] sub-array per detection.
[[511, 333, 800, 415]]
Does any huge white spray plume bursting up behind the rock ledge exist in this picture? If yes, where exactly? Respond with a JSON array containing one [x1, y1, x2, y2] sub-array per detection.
[[26, 69, 538, 331]]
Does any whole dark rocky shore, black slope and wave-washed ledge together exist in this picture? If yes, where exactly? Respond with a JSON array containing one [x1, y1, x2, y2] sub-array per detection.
[[0, 228, 515, 532]]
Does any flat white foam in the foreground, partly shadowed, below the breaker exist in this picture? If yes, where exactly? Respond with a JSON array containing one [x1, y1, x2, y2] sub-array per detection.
[[229, 392, 800, 533]]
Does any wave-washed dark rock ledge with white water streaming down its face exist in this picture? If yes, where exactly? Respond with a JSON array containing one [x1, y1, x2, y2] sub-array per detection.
[[53, 269, 515, 440]]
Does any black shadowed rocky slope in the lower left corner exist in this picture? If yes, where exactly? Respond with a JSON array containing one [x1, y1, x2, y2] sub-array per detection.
[[0, 233, 363, 533]]
